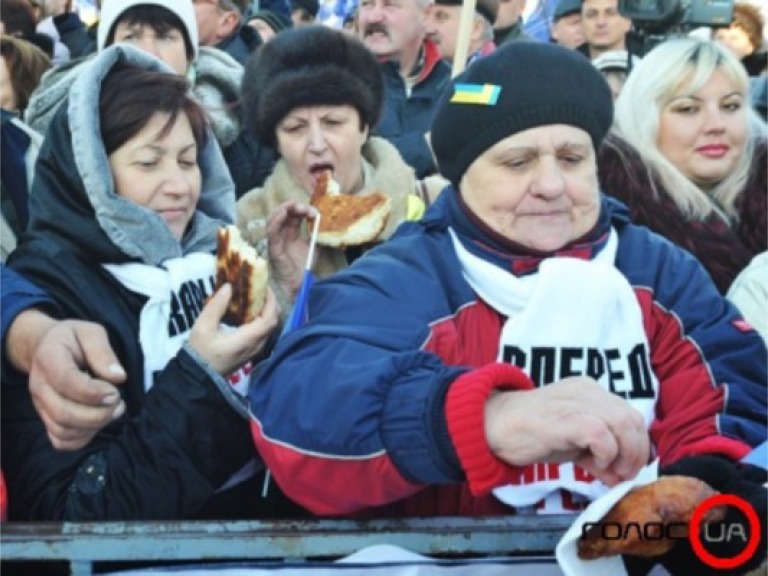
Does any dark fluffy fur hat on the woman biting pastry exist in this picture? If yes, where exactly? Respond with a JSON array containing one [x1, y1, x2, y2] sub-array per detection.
[[242, 25, 384, 147]]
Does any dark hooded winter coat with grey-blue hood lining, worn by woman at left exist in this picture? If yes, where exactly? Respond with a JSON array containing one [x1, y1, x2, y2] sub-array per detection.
[[0, 46, 276, 521]]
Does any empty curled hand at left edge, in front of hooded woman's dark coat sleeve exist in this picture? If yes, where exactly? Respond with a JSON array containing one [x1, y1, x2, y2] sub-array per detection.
[[29, 320, 126, 450]]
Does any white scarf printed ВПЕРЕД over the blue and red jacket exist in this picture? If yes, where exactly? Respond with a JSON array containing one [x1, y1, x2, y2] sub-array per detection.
[[450, 229, 658, 513]]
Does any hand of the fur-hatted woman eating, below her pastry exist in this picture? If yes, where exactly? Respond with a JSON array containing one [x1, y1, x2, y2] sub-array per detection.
[[267, 201, 315, 298]]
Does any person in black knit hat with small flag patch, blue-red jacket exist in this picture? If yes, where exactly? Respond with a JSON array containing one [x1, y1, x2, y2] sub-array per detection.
[[250, 42, 767, 575]]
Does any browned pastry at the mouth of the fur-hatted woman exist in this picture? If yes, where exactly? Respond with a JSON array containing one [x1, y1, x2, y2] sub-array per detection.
[[310, 170, 391, 247]]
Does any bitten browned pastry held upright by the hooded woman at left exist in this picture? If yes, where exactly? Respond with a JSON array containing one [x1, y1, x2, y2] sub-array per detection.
[[216, 226, 269, 326]]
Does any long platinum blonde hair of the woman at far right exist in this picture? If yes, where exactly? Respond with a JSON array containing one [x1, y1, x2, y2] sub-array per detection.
[[607, 38, 765, 219]]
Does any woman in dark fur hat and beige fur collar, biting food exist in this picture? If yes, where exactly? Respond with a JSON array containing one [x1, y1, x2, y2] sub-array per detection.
[[237, 26, 447, 313]]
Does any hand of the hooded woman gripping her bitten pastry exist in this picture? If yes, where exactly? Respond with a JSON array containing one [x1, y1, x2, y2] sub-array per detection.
[[189, 284, 280, 376]]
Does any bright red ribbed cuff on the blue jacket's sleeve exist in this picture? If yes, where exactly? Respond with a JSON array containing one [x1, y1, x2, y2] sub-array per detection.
[[445, 364, 534, 496]]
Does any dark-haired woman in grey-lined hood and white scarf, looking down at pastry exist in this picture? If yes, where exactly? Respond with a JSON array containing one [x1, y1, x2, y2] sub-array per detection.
[[0, 45, 294, 521]]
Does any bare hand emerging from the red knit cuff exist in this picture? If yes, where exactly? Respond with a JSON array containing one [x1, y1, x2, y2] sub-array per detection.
[[485, 376, 650, 486]]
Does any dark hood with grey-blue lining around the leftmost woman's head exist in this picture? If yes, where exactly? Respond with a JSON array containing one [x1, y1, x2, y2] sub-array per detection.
[[19, 45, 235, 265]]
